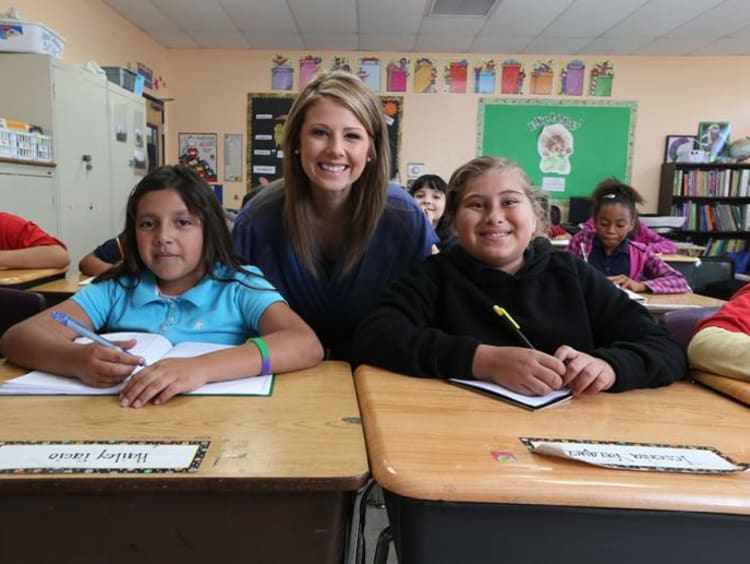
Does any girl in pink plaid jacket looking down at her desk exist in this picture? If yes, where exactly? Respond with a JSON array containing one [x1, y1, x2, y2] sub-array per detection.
[[568, 181, 690, 294]]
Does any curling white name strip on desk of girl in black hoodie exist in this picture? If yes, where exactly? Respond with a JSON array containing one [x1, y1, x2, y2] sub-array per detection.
[[524, 439, 747, 473]]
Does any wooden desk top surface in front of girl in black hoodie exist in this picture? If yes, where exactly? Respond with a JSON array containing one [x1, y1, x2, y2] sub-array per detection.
[[355, 366, 750, 514]]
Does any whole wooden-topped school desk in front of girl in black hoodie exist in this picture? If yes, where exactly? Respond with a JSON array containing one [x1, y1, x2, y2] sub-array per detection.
[[355, 366, 750, 564]]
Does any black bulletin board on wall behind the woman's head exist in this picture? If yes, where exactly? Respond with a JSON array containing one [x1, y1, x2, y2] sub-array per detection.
[[247, 93, 403, 192]]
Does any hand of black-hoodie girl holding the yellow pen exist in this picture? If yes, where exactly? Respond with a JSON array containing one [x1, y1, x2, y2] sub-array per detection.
[[472, 345, 565, 396]]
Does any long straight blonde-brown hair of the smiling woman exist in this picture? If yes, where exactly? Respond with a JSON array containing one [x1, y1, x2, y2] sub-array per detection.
[[284, 71, 391, 276]]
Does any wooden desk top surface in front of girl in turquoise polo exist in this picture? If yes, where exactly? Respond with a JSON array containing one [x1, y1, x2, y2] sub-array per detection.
[[0, 362, 369, 492]]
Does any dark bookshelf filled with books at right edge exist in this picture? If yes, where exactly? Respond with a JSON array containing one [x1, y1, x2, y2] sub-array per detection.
[[658, 163, 750, 255]]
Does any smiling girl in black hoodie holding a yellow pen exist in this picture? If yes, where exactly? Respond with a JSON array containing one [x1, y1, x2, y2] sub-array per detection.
[[354, 157, 687, 395]]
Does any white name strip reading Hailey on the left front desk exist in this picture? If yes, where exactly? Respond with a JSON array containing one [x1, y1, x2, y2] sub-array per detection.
[[0, 443, 200, 470]]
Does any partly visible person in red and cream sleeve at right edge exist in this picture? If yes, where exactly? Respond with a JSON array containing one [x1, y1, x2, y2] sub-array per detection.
[[687, 284, 750, 380]]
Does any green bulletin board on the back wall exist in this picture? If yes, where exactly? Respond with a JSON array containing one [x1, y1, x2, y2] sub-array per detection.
[[477, 98, 637, 198]]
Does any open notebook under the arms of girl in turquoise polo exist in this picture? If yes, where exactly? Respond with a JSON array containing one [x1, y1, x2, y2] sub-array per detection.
[[0, 332, 273, 396]]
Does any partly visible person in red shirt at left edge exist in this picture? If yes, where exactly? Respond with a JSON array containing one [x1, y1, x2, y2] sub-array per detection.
[[0, 212, 70, 268]]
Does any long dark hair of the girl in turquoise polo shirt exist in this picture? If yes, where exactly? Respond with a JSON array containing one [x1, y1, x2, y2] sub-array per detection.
[[96, 165, 257, 285]]
